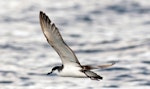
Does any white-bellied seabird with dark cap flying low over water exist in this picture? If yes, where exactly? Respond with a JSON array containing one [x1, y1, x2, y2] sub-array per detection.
[[39, 11, 115, 80]]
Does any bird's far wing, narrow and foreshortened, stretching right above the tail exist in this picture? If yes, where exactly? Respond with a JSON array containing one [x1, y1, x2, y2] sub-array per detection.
[[82, 62, 116, 70]]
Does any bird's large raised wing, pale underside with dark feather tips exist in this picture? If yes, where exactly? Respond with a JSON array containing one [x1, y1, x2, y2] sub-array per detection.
[[39, 11, 80, 66]]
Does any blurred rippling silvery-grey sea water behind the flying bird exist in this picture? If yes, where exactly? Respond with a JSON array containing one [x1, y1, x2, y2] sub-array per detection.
[[0, 0, 150, 89]]
